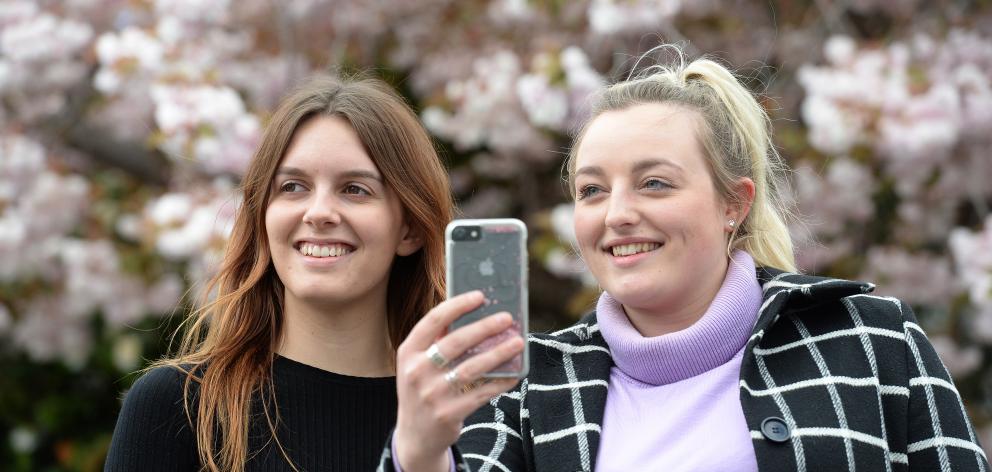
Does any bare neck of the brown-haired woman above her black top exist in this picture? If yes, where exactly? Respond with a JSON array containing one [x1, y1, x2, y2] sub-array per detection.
[[276, 297, 395, 377]]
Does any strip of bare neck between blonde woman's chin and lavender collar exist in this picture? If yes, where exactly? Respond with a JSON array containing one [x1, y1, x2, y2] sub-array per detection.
[[623, 259, 728, 338]]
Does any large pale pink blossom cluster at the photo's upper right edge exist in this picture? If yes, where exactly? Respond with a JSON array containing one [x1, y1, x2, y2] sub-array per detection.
[[799, 30, 992, 198]]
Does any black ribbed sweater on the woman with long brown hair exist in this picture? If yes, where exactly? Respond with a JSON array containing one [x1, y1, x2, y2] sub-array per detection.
[[104, 356, 396, 471]]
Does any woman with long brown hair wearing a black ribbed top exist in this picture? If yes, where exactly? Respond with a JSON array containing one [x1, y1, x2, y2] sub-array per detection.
[[105, 73, 452, 471]]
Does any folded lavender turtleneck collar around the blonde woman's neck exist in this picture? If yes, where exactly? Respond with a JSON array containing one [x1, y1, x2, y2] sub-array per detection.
[[596, 251, 761, 385]]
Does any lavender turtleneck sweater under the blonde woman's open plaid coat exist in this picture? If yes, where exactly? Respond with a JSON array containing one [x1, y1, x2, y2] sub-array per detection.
[[596, 251, 761, 472]]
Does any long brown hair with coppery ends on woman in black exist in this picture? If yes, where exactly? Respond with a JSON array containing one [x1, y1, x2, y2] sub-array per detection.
[[153, 75, 453, 472]]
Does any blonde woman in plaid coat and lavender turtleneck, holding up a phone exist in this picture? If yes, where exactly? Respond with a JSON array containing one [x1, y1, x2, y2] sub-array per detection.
[[392, 51, 990, 472]]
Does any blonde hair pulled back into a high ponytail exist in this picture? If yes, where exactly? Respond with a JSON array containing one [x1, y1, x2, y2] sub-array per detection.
[[567, 45, 796, 271]]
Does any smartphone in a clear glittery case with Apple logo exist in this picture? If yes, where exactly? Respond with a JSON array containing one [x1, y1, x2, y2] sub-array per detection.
[[444, 218, 529, 378]]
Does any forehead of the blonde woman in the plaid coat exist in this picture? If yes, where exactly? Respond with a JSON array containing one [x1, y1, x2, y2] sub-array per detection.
[[575, 103, 707, 172]]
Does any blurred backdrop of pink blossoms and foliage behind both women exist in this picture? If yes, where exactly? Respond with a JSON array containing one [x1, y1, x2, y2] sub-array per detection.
[[0, 0, 992, 470]]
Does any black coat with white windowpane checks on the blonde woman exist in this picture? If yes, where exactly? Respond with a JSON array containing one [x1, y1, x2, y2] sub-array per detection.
[[383, 269, 992, 472]]
